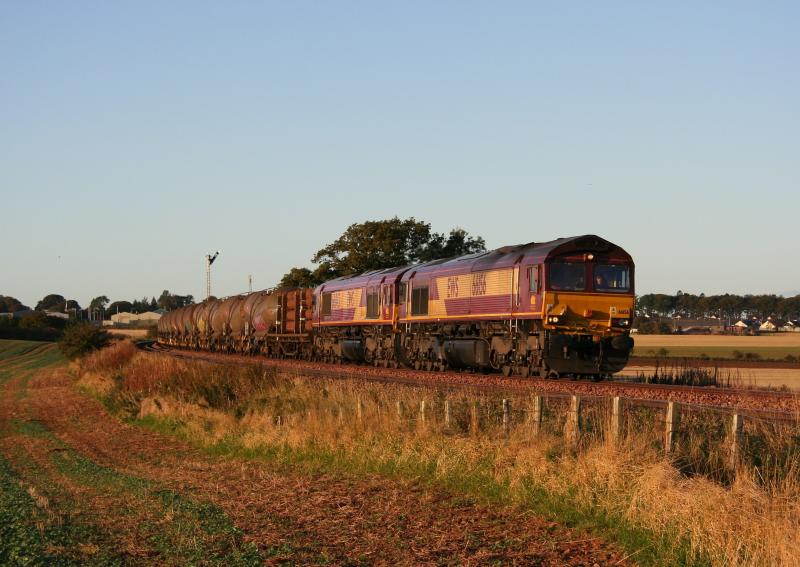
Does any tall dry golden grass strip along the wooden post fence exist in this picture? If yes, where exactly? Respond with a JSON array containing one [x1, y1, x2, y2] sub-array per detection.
[[87, 355, 800, 565]]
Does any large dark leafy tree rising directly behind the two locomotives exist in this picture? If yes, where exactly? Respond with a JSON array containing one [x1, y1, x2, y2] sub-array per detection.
[[281, 217, 486, 287]]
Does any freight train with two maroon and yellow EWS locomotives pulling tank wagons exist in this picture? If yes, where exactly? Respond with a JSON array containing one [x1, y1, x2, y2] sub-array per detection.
[[158, 235, 635, 379]]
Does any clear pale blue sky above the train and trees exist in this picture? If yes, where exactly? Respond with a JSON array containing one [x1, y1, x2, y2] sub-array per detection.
[[0, 0, 800, 305]]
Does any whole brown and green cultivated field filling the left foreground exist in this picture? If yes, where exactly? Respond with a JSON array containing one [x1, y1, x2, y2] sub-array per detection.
[[0, 341, 630, 566]]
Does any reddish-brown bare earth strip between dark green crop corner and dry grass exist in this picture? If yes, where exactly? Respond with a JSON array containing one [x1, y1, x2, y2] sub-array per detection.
[[0, 358, 625, 566]]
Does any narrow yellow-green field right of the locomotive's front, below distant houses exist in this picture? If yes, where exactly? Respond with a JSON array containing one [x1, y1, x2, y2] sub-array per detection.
[[633, 333, 800, 360]]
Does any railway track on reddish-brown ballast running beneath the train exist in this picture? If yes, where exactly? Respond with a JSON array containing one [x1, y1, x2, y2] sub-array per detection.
[[138, 341, 800, 419]]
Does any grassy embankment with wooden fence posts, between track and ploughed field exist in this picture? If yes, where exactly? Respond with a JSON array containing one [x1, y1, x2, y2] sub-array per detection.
[[122, 340, 800, 565]]
